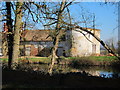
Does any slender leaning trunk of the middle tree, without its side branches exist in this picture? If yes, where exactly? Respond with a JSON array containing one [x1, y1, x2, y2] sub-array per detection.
[[48, 0, 66, 75]]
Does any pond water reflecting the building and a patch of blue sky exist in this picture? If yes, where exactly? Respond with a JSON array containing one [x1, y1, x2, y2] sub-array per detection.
[[7, 64, 120, 78]]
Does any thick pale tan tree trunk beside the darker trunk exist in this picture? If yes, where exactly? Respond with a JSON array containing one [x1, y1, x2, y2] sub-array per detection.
[[12, 2, 23, 63]]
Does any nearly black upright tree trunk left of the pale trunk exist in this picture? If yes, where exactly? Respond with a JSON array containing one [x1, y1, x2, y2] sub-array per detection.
[[6, 2, 13, 68]]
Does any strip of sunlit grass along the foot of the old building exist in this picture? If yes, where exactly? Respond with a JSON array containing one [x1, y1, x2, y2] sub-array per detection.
[[0, 56, 117, 63]]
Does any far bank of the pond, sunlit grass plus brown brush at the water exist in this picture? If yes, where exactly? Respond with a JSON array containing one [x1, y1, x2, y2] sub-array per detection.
[[1, 56, 120, 68]]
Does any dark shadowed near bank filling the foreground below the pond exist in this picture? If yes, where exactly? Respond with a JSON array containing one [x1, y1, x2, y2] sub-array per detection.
[[2, 69, 120, 88]]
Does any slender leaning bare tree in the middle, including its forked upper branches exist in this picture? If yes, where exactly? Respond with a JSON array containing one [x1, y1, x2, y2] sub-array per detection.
[[48, 0, 72, 75]]
